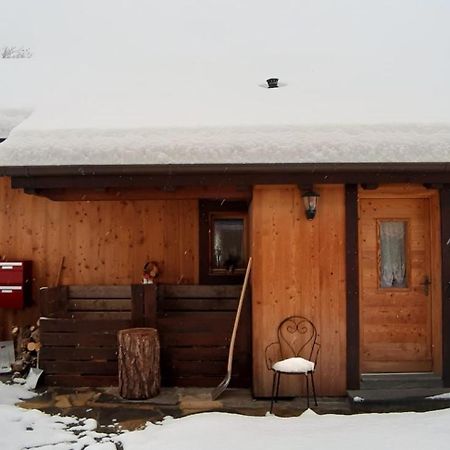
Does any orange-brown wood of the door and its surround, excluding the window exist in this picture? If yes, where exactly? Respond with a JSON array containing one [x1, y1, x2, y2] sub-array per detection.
[[359, 192, 441, 373]]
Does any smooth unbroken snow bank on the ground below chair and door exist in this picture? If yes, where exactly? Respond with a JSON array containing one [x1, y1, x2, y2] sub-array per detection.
[[119, 410, 450, 450]]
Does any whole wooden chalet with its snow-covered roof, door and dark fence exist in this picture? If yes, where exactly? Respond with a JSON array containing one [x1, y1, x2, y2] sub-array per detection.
[[0, 1, 450, 397]]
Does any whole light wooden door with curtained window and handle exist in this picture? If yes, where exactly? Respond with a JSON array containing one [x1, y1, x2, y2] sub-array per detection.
[[359, 198, 433, 373]]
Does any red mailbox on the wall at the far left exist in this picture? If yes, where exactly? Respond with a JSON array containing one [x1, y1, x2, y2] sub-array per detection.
[[0, 261, 31, 309]]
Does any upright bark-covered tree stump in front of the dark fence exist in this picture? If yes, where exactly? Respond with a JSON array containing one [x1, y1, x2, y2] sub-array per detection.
[[117, 328, 161, 400]]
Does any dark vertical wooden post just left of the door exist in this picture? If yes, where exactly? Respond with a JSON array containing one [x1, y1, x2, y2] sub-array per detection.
[[345, 184, 360, 389]]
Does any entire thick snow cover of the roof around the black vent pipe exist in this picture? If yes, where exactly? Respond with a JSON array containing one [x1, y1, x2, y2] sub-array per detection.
[[0, 0, 450, 166]]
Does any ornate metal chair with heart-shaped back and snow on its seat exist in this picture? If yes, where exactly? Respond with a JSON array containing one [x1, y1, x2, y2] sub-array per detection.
[[265, 316, 320, 412]]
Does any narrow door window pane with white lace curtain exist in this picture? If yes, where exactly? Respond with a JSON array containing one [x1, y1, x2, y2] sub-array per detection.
[[379, 221, 408, 288]]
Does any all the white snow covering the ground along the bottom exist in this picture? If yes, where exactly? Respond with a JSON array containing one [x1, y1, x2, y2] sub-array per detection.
[[0, 383, 450, 450]]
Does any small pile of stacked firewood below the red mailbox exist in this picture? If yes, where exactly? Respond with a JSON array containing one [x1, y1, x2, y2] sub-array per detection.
[[11, 320, 41, 377]]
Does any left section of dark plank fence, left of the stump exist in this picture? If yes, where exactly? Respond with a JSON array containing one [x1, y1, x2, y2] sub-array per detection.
[[40, 285, 133, 386]]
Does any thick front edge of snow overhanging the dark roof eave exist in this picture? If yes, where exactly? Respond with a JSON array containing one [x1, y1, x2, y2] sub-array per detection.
[[0, 125, 450, 166]]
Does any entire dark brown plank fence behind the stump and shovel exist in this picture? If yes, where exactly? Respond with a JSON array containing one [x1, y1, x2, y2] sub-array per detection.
[[40, 285, 252, 387]]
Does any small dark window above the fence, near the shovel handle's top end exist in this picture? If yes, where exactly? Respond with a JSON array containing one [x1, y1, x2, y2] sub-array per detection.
[[211, 218, 245, 272]]
